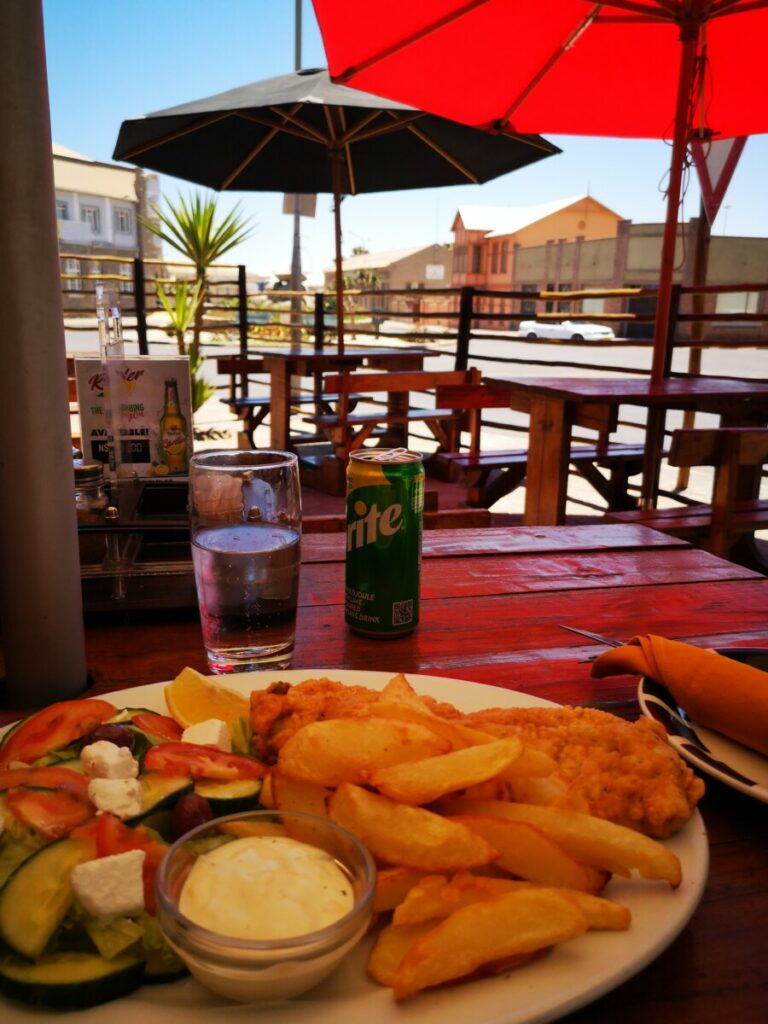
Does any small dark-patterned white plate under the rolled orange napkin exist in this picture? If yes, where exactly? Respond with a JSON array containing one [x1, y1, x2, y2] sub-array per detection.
[[637, 648, 768, 804]]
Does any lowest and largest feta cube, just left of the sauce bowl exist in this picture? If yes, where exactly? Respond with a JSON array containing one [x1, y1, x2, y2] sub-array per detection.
[[70, 850, 146, 918]]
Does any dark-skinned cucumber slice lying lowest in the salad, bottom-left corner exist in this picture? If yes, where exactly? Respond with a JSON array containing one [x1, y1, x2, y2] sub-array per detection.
[[0, 952, 144, 1010]]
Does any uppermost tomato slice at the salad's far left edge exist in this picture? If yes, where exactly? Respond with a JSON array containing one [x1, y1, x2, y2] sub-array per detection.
[[0, 697, 116, 768]]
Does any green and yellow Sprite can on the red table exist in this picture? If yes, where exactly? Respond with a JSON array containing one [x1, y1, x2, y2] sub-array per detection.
[[345, 449, 424, 637]]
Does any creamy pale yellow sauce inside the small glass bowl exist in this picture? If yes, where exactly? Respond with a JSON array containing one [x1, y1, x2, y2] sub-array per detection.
[[179, 836, 354, 940]]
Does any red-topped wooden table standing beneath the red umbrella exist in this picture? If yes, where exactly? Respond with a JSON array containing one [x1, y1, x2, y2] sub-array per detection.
[[485, 377, 768, 525]]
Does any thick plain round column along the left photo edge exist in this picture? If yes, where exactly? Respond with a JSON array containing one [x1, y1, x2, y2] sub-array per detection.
[[0, 0, 86, 709]]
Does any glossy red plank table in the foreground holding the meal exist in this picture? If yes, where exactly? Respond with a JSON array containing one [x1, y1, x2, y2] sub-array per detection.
[[0, 524, 768, 1024]]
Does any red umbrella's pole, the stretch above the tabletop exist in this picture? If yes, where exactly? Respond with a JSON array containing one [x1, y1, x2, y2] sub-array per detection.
[[650, 19, 699, 384]]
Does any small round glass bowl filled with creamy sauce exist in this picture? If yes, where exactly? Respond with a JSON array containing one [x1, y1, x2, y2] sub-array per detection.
[[156, 810, 376, 1002]]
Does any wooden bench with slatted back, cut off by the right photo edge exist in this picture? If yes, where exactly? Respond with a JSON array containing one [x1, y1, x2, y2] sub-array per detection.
[[606, 427, 768, 571]]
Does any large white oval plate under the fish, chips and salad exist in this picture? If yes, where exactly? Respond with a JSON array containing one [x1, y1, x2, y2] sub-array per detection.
[[0, 669, 709, 1024]]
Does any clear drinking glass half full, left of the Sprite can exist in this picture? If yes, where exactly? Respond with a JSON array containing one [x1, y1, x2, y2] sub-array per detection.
[[189, 450, 301, 673]]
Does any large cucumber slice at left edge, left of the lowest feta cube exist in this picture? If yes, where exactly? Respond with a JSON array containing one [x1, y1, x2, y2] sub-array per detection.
[[0, 839, 95, 959]]
